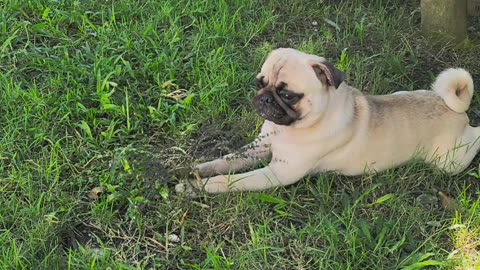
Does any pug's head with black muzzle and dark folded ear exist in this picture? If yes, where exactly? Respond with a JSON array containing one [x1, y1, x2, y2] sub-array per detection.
[[254, 48, 345, 127]]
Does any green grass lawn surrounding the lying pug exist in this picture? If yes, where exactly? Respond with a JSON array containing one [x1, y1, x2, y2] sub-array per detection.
[[0, 0, 480, 270]]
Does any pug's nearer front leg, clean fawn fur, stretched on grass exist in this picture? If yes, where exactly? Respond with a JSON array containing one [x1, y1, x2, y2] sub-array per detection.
[[202, 162, 307, 193]]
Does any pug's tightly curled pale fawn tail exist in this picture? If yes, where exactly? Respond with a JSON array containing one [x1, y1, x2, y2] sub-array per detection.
[[432, 68, 473, 113]]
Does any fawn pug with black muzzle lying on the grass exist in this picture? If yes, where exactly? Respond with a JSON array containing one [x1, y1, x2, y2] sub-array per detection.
[[176, 48, 480, 193]]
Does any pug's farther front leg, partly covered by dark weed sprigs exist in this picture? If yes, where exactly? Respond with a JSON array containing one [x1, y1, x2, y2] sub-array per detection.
[[194, 138, 271, 177]]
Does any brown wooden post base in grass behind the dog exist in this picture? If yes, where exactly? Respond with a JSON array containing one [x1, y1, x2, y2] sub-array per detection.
[[420, 0, 467, 42]]
